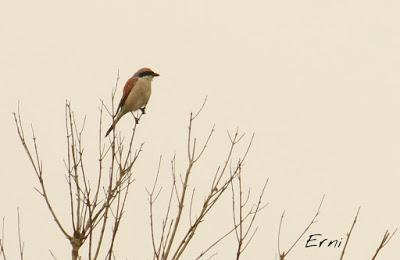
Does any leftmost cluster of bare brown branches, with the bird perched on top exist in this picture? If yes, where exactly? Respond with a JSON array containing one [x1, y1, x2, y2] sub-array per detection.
[[15, 72, 143, 260]]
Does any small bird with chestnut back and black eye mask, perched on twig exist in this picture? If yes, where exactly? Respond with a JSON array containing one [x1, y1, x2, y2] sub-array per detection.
[[105, 67, 160, 137]]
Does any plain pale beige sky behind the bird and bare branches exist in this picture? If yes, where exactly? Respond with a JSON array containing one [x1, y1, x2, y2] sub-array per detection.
[[0, 0, 400, 260]]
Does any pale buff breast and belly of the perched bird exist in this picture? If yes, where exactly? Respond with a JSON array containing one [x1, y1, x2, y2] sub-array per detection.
[[124, 79, 151, 111]]
